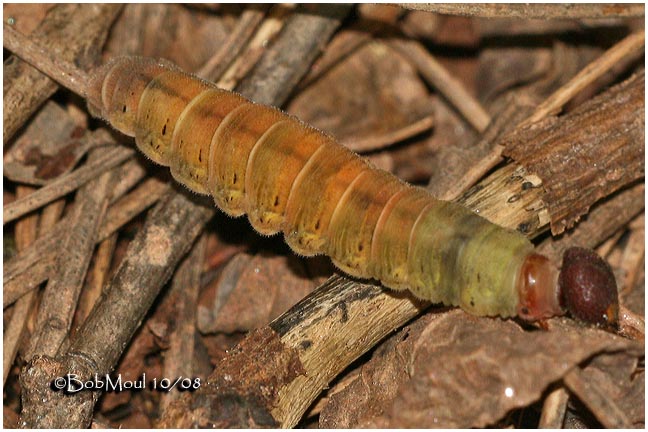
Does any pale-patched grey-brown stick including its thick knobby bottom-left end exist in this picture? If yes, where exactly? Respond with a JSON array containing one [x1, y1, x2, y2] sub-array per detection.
[[21, 191, 213, 427]]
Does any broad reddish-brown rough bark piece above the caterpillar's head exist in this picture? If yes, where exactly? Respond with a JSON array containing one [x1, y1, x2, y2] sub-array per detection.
[[503, 72, 645, 235]]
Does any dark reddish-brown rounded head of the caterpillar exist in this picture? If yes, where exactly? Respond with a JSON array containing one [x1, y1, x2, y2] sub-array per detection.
[[558, 247, 619, 325]]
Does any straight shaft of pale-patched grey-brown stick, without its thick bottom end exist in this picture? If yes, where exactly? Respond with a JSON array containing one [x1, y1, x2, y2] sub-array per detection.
[[64, 190, 213, 382]]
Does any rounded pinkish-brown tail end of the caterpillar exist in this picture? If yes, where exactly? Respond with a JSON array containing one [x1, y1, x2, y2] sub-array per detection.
[[87, 57, 175, 136]]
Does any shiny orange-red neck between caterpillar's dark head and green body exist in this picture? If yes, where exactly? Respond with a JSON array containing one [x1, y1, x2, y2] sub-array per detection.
[[517, 253, 563, 321]]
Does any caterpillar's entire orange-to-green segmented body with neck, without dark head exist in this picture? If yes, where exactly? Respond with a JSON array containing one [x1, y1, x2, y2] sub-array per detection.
[[87, 57, 613, 321]]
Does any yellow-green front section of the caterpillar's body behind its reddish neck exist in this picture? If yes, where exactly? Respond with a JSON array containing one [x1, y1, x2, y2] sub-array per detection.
[[407, 200, 533, 317]]
